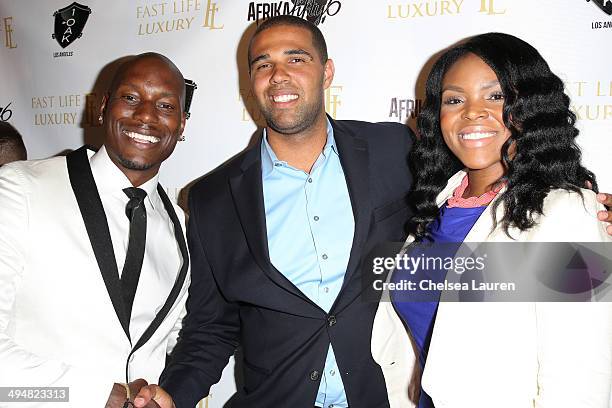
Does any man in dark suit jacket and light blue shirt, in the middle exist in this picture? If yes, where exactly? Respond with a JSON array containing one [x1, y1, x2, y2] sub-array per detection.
[[135, 16, 412, 408]]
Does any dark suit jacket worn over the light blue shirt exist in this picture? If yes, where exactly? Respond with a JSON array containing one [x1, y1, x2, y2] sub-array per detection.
[[160, 121, 413, 408]]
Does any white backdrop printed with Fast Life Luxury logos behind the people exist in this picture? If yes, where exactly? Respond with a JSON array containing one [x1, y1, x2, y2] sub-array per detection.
[[0, 0, 612, 408]]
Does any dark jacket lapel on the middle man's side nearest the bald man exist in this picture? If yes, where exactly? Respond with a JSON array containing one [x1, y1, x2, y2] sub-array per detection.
[[229, 143, 314, 304]]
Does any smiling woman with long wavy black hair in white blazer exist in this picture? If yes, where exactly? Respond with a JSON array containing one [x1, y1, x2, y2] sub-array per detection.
[[372, 33, 612, 408]]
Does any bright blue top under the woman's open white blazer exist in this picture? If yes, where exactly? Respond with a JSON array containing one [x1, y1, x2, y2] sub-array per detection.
[[391, 204, 487, 408]]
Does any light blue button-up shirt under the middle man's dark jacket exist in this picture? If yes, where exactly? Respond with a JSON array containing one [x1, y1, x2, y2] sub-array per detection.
[[261, 121, 355, 408]]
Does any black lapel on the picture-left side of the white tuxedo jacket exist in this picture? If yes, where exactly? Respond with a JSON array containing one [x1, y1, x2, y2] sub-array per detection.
[[66, 146, 130, 339]]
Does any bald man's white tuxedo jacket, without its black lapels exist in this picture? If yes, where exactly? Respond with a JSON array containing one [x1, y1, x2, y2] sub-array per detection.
[[0, 157, 189, 408]]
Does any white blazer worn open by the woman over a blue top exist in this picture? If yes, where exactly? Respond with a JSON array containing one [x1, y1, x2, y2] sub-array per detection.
[[372, 171, 612, 408]]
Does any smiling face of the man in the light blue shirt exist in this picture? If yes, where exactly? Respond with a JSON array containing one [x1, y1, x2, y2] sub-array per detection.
[[249, 25, 334, 135]]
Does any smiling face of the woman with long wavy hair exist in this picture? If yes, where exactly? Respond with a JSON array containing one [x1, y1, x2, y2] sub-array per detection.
[[440, 54, 511, 179]]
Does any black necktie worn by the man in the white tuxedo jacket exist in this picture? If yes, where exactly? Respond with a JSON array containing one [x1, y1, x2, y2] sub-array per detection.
[[121, 187, 147, 326]]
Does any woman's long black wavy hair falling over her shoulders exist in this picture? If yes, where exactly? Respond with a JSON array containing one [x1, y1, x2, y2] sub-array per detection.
[[407, 33, 597, 240]]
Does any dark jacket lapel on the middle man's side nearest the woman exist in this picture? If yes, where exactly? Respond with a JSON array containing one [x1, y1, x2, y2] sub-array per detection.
[[329, 118, 372, 292]]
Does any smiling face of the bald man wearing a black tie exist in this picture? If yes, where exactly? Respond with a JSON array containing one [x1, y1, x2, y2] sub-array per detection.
[[101, 56, 185, 186]]
